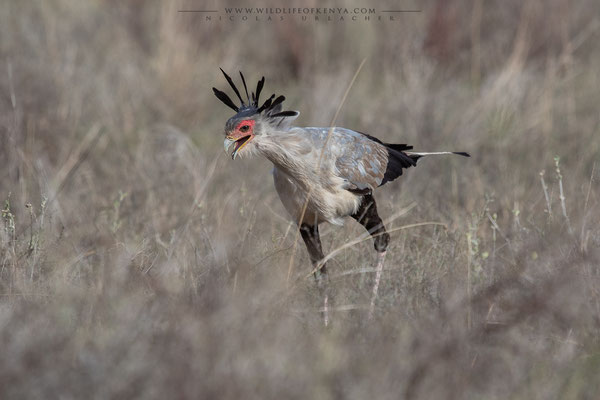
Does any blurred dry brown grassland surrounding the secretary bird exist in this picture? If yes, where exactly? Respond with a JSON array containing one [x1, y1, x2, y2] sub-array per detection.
[[0, 0, 600, 399]]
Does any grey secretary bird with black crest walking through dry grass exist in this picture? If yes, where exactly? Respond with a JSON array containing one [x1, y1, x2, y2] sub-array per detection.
[[213, 69, 470, 318]]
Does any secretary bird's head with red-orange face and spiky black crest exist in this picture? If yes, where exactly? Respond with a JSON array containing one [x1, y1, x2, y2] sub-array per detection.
[[213, 69, 300, 159]]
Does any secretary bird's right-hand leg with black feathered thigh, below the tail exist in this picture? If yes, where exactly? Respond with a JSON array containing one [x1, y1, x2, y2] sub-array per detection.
[[352, 193, 390, 319]]
